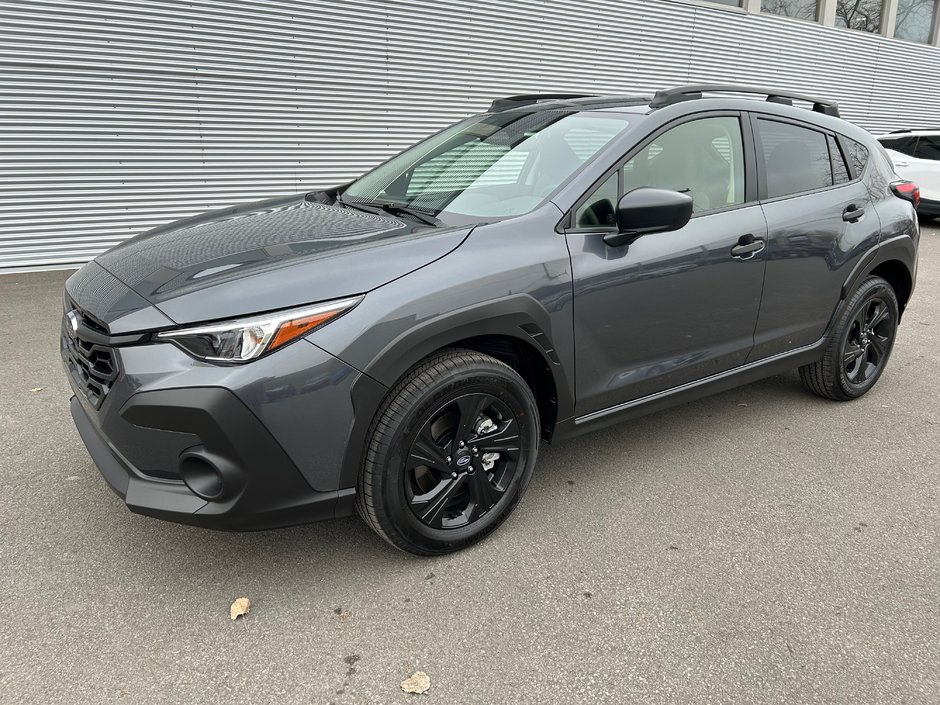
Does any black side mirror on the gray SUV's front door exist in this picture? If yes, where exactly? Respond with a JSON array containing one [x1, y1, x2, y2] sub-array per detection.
[[604, 187, 692, 247]]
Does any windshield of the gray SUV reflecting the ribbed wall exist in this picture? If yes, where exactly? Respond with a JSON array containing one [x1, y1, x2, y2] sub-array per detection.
[[342, 110, 628, 218]]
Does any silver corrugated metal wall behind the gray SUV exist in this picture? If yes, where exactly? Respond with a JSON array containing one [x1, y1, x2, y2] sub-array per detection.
[[0, 0, 940, 268]]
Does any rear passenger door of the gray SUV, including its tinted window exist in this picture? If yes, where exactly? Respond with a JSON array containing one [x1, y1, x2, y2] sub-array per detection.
[[748, 115, 881, 361]]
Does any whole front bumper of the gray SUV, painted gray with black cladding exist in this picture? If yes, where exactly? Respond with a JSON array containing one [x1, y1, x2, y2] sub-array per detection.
[[62, 320, 386, 530]]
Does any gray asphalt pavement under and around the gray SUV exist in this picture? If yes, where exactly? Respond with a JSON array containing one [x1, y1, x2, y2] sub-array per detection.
[[0, 221, 940, 705]]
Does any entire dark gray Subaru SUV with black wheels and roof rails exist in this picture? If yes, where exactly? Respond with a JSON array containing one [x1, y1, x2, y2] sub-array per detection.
[[61, 85, 919, 554]]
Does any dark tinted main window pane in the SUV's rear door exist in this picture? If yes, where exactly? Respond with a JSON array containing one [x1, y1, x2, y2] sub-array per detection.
[[757, 119, 832, 198]]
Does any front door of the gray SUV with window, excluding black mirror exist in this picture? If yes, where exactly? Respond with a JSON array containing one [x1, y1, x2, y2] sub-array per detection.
[[566, 114, 767, 415]]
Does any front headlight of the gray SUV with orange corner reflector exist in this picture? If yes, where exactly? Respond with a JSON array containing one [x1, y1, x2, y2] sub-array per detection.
[[155, 296, 363, 362]]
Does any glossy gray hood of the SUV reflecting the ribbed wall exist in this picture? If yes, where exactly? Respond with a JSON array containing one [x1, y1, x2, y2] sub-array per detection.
[[81, 195, 470, 330]]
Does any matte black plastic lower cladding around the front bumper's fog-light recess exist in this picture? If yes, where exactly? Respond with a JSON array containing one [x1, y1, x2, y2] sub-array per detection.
[[71, 394, 355, 531]]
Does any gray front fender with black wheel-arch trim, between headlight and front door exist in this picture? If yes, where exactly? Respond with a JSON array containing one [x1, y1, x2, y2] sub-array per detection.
[[307, 209, 575, 484]]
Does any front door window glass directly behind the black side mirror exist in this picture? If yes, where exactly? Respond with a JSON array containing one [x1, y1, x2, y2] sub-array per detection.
[[623, 117, 744, 213]]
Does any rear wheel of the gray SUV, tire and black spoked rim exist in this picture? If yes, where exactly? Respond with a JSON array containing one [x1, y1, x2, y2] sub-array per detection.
[[800, 277, 898, 401]]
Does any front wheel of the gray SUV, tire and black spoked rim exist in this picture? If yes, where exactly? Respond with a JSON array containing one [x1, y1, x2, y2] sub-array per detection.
[[356, 349, 540, 556]]
